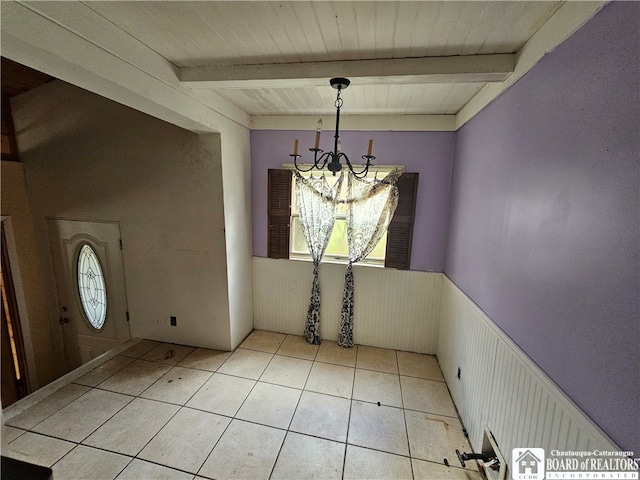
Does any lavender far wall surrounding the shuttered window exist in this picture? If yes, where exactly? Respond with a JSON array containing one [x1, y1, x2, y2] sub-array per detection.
[[251, 130, 455, 272]]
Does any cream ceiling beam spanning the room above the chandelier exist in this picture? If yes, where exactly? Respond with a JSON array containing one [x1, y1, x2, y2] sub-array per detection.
[[178, 54, 516, 88]]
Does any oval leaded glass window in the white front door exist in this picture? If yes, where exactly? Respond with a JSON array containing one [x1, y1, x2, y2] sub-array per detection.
[[78, 244, 107, 330]]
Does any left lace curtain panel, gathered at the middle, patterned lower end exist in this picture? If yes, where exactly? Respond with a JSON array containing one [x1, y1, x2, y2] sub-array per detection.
[[293, 171, 343, 345]]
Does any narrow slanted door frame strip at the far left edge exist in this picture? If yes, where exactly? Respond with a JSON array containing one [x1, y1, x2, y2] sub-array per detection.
[[2, 215, 40, 392]]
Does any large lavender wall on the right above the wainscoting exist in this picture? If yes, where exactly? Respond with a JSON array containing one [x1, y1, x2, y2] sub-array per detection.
[[445, 2, 640, 456]]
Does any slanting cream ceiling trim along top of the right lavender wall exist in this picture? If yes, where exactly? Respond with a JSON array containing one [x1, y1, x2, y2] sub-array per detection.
[[456, 1, 609, 130]]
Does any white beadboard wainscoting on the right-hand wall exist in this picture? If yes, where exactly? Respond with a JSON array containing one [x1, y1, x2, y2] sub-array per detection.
[[437, 276, 620, 462]]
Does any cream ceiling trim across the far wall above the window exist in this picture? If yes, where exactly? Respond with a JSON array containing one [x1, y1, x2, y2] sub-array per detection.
[[251, 115, 456, 132]]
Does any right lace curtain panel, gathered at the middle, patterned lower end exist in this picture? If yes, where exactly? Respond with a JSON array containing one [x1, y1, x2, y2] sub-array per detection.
[[338, 169, 402, 347]]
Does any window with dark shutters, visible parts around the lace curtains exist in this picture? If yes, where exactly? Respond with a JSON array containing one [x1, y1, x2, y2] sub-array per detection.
[[268, 169, 418, 269]]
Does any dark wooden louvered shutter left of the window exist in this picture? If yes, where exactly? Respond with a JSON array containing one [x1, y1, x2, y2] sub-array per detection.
[[267, 169, 291, 258]]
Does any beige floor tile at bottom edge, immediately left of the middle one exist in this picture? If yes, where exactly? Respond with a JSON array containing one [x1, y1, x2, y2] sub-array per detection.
[[198, 420, 286, 480]]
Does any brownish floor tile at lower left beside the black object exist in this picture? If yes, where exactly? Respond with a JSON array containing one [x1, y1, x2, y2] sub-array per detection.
[[2, 432, 76, 467]]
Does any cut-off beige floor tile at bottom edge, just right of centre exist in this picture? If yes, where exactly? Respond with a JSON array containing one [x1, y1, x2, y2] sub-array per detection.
[[343, 445, 413, 480]]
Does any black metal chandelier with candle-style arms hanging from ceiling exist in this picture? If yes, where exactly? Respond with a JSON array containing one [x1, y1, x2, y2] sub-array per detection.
[[289, 78, 376, 178]]
